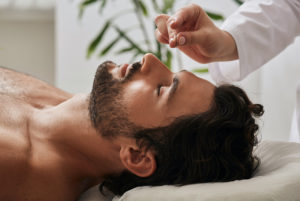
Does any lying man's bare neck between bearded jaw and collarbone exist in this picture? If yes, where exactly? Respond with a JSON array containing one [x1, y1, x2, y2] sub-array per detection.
[[33, 94, 122, 188]]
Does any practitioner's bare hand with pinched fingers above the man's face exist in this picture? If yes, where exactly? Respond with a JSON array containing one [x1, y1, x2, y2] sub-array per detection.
[[155, 4, 238, 63]]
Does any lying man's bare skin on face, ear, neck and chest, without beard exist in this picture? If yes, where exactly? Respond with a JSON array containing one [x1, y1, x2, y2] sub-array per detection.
[[0, 54, 214, 201]]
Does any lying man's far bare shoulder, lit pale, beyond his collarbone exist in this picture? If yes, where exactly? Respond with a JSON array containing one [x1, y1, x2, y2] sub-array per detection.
[[0, 67, 73, 108]]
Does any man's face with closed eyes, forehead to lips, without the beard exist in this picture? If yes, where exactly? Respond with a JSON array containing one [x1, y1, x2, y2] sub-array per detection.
[[89, 54, 215, 135]]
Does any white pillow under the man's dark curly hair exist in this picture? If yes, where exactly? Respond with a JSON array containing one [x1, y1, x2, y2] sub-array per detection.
[[80, 141, 300, 201]]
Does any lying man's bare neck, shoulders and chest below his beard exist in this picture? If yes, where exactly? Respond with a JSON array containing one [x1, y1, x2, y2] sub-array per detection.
[[0, 68, 124, 201]]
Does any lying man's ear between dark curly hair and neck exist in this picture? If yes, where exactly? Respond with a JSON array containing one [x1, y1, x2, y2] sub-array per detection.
[[120, 145, 156, 177]]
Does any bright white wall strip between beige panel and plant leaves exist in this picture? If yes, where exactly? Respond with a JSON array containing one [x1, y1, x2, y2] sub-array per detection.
[[55, 0, 102, 93]]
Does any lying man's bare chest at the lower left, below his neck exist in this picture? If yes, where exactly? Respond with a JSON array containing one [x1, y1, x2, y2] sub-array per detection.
[[0, 95, 78, 201]]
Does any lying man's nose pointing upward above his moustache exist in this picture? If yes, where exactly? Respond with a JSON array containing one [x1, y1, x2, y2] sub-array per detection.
[[141, 53, 169, 74]]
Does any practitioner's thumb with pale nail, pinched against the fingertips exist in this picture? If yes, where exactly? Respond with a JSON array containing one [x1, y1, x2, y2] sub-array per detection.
[[176, 30, 207, 46]]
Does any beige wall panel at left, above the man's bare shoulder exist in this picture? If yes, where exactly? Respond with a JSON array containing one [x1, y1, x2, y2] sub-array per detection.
[[0, 16, 54, 84]]
